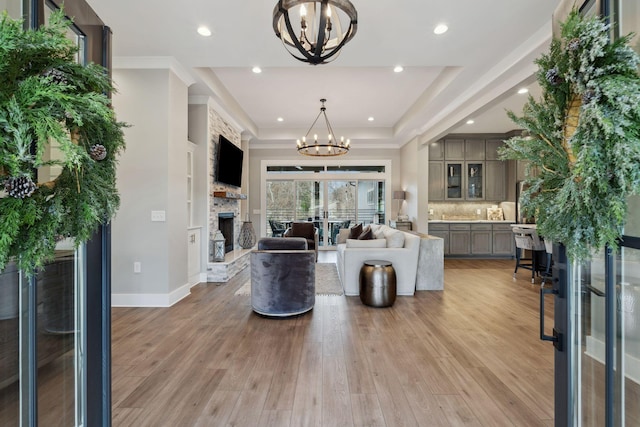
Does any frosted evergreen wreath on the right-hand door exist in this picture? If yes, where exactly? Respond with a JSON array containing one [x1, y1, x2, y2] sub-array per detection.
[[501, 10, 640, 260]]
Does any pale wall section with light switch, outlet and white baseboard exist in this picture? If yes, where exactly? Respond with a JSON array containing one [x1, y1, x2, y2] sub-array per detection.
[[112, 69, 188, 306]]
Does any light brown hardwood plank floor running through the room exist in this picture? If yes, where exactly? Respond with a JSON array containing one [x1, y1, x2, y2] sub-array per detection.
[[112, 254, 553, 427]]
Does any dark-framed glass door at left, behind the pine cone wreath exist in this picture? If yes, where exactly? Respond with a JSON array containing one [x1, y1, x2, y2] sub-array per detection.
[[0, 0, 111, 427]]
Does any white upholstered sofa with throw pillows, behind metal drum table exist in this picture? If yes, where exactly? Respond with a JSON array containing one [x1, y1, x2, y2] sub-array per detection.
[[337, 224, 420, 296]]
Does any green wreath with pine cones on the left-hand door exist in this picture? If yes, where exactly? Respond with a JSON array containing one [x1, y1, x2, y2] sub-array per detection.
[[0, 10, 126, 275]]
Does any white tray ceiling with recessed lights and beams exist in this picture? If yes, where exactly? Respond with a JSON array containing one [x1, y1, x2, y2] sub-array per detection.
[[88, 0, 559, 147]]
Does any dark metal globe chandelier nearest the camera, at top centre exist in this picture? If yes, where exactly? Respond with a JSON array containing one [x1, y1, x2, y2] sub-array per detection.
[[273, 0, 358, 65]]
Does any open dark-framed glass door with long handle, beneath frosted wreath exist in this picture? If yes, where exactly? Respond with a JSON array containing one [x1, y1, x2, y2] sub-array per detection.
[[540, 196, 640, 427]]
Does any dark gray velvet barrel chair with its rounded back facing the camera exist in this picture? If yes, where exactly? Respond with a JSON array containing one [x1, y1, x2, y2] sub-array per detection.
[[251, 237, 316, 317]]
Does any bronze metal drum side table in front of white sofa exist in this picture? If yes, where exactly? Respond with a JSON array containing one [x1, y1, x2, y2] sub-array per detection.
[[360, 260, 396, 307]]
